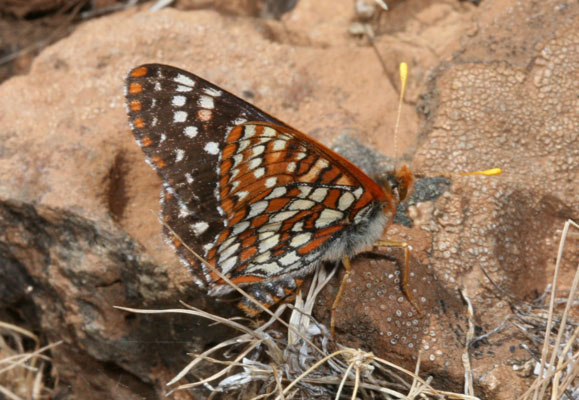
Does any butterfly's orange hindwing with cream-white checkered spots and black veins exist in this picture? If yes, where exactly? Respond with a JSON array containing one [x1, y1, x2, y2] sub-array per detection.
[[208, 122, 393, 314]]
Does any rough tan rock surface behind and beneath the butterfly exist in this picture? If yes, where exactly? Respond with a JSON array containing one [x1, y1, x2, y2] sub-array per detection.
[[0, 0, 579, 399]]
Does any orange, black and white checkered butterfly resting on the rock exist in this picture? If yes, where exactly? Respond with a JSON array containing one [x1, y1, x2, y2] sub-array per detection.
[[125, 64, 414, 316]]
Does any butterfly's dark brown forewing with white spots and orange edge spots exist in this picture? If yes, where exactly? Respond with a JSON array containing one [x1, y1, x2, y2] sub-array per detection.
[[125, 64, 287, 285]]
